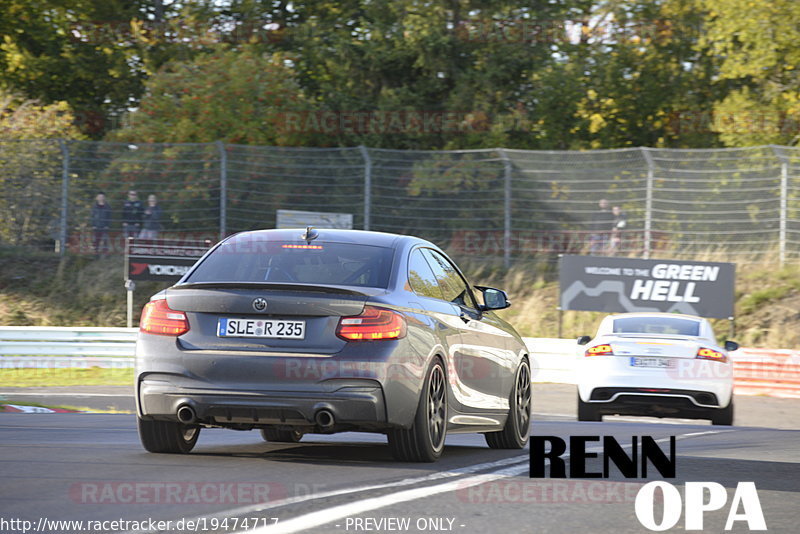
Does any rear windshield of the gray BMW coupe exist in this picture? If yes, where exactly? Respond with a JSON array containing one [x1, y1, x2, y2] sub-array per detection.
[[184, 239, 393, 288]]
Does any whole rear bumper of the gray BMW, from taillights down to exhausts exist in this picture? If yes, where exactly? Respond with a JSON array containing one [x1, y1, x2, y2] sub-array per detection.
[[136, 333, 427, 430]]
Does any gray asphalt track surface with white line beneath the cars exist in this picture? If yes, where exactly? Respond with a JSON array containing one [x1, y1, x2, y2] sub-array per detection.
[[0, 386, 800, 534]]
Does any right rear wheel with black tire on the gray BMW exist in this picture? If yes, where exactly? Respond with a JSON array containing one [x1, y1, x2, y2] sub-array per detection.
[[387, 358, 447, 462]]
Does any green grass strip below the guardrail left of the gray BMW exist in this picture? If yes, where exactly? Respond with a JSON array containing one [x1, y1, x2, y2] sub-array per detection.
[[0, 367, 133, 387]]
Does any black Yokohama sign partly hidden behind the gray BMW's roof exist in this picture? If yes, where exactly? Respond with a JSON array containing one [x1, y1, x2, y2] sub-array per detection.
[[125, 239, 211, 282]]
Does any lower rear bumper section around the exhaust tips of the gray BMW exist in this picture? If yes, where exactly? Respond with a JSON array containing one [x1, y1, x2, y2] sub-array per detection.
[[137, 377, 388, 431]]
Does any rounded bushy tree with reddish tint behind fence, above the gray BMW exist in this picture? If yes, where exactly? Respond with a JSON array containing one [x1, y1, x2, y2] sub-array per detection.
[[110, 48, 307, 146]]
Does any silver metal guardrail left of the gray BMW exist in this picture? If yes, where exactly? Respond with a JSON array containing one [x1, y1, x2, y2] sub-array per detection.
[[0, 326, 137, 369]]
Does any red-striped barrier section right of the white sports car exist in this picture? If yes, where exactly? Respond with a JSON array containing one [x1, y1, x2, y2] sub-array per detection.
[[731, 348, 800, 399]]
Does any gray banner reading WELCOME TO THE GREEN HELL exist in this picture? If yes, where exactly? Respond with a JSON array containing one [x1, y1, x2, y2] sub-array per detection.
[[558, 255, 735, 319]]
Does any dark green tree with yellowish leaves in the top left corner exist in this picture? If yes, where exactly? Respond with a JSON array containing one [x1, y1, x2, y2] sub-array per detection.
[[0, 0, 159, 136]]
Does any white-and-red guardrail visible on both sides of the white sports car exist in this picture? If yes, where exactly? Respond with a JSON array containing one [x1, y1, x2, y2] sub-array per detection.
[[524, 338, 800, 399]]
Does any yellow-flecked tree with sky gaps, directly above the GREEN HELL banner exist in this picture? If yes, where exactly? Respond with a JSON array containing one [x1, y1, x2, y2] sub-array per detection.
[[564, 0, 717, 148]]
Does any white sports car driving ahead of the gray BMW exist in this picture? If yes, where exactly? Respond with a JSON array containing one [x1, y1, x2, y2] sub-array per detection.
[[577, 313, 739, 425]]
